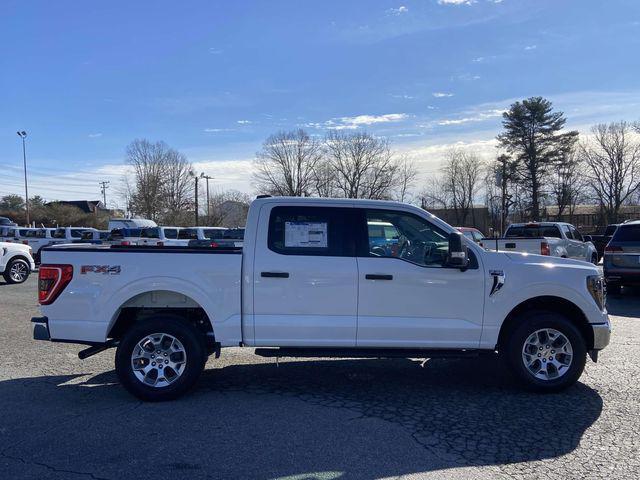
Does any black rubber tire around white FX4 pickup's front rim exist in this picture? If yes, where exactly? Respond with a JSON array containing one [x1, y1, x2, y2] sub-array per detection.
[[504, 310, 587, 393]]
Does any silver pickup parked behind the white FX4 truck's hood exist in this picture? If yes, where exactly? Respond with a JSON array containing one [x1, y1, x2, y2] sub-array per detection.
[[490, 222, 598, 264]]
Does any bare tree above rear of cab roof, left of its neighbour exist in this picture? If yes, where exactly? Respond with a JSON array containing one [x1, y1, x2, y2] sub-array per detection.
[[253, 129, 322, 197]]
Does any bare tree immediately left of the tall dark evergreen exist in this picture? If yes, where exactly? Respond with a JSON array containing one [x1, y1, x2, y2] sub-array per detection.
[[442, 148, 483, 225]]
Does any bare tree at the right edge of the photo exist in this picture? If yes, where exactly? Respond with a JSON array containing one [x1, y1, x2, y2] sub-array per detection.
[[580, 121, 640, 223]]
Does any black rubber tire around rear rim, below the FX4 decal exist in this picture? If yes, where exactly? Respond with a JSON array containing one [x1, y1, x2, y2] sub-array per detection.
[[115, 316, 207, 402]]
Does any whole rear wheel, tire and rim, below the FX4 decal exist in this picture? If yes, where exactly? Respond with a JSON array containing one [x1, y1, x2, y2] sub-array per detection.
[[115, 317, 207, 402]]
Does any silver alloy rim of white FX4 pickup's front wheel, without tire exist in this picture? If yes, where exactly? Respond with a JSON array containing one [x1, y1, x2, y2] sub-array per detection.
[[522, 328, 573, 380]]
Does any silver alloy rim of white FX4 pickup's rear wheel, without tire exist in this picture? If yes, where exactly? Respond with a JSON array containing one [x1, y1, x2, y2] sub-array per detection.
[[131, 333, 187, 388]]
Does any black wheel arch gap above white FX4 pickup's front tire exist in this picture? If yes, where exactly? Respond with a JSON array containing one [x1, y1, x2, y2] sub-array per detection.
[[496, 295, 593, 350]]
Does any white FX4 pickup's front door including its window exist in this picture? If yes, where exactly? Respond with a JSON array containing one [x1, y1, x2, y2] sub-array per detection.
[[357, 210, 485, 348]]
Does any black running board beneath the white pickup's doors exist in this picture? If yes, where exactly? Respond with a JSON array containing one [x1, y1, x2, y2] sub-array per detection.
[[255, 347, 484, 358]]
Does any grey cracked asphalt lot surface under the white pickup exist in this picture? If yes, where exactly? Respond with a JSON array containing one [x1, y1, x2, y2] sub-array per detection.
[[0, 275, 640, 480]]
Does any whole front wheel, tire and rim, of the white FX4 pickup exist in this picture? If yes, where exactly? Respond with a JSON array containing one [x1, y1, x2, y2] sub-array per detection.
[[505, 311, 587, 392]]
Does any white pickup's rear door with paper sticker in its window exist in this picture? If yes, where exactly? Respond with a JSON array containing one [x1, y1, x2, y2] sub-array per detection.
[[253, 204, 358, 347]]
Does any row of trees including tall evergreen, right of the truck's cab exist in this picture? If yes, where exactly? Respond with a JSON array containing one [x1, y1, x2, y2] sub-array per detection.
[[421, 97, 640, 230]]
